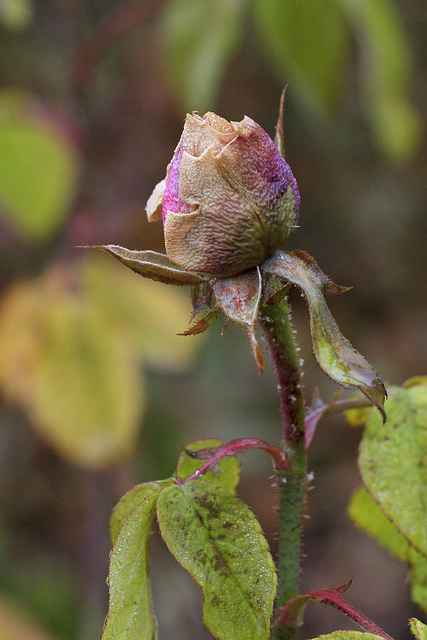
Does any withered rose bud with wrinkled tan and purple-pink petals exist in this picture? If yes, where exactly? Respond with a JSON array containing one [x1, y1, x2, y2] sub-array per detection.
[[147, 112, 300, 277]]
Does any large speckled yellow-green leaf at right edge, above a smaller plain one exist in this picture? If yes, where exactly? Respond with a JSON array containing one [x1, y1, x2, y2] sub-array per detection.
[[359, 384, 427, 557]]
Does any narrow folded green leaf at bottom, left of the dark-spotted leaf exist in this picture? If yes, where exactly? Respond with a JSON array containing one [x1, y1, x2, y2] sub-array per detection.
[[102, 491, 161, 640]]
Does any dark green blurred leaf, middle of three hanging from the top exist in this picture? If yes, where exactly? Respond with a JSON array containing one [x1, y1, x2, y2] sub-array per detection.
[[254, 0, 349, 113]]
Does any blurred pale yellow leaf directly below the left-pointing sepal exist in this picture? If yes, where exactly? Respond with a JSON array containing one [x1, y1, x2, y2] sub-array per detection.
[[79, 252, 199, 372]]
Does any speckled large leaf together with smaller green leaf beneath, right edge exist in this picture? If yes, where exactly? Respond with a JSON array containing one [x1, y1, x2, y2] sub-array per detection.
[[349, 377, 427, 612]]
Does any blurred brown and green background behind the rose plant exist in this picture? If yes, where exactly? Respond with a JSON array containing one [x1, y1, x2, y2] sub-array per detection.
[[0, 0, 427, 640]]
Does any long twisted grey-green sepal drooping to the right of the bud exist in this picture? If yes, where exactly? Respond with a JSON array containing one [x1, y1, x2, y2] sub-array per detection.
[[261, 251, 386, 421]]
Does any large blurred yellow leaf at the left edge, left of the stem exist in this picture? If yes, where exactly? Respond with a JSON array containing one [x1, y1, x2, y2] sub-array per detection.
[[0, 266, 144, 468]]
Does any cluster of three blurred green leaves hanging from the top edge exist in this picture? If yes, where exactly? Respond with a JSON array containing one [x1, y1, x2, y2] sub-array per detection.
[[161, 0, 423, 159]]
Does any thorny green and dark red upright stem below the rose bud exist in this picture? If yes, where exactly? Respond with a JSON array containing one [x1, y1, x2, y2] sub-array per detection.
[[260, 299, 307, 640]]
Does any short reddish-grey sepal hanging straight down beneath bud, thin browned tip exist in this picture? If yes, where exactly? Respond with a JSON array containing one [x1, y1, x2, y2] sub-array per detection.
[[212, 267, 265, 374]]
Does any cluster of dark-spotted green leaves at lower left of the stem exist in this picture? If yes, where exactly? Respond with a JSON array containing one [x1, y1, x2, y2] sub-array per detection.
[[102, 439, 276, 640]]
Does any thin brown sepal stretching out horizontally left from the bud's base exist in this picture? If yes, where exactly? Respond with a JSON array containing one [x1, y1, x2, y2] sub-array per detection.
[[88, 244, 209, 286]]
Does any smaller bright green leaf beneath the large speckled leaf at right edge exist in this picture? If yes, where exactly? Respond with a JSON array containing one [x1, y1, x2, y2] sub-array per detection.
[[348, 488, 427, 611]]
